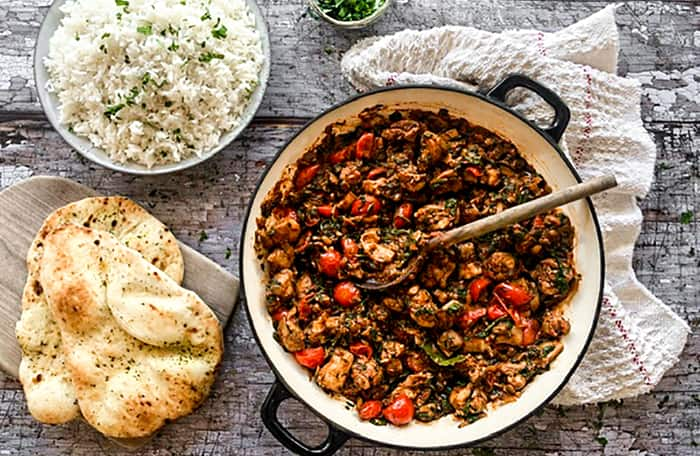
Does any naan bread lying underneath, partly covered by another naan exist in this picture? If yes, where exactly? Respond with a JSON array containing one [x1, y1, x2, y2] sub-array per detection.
[[16, 197, 184, 424]]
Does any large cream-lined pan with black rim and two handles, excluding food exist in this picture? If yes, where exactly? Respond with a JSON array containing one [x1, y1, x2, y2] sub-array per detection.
[[241, 75, 604, 454]]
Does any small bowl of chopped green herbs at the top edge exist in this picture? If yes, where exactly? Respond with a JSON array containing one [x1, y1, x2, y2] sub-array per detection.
[[309, 0, 390, 29]]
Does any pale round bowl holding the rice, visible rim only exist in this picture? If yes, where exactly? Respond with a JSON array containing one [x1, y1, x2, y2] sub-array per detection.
[[34, 0, 270, 175]]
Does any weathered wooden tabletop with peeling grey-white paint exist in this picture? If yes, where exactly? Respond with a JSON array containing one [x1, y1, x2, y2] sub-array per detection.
[[0, 0, 700, 456]]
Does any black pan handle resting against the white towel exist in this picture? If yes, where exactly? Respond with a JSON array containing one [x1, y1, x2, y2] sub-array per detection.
[[488, 73, 571, 143]]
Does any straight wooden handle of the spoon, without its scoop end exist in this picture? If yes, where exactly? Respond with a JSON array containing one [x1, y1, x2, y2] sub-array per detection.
[[430, 175, 617, 247]]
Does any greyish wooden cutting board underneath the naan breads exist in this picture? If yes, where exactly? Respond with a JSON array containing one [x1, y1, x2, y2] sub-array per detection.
[[0, 176, 238, 377]]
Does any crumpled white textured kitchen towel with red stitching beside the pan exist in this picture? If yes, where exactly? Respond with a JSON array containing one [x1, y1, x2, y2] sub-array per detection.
[[342, 2, 690, 405]]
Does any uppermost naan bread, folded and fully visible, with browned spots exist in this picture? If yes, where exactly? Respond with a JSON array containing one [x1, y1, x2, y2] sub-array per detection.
[[40, 225, 223, 438]]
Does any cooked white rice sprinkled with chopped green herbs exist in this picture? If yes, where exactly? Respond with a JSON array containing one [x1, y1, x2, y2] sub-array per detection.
[[44, 0, 263, 167]]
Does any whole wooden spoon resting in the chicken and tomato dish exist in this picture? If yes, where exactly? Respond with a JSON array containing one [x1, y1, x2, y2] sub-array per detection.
[[357, 175, 617, 290]]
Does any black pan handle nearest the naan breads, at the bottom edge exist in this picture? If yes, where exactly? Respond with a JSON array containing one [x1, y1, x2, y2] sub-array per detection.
[[261, 380, 350, 456]]
